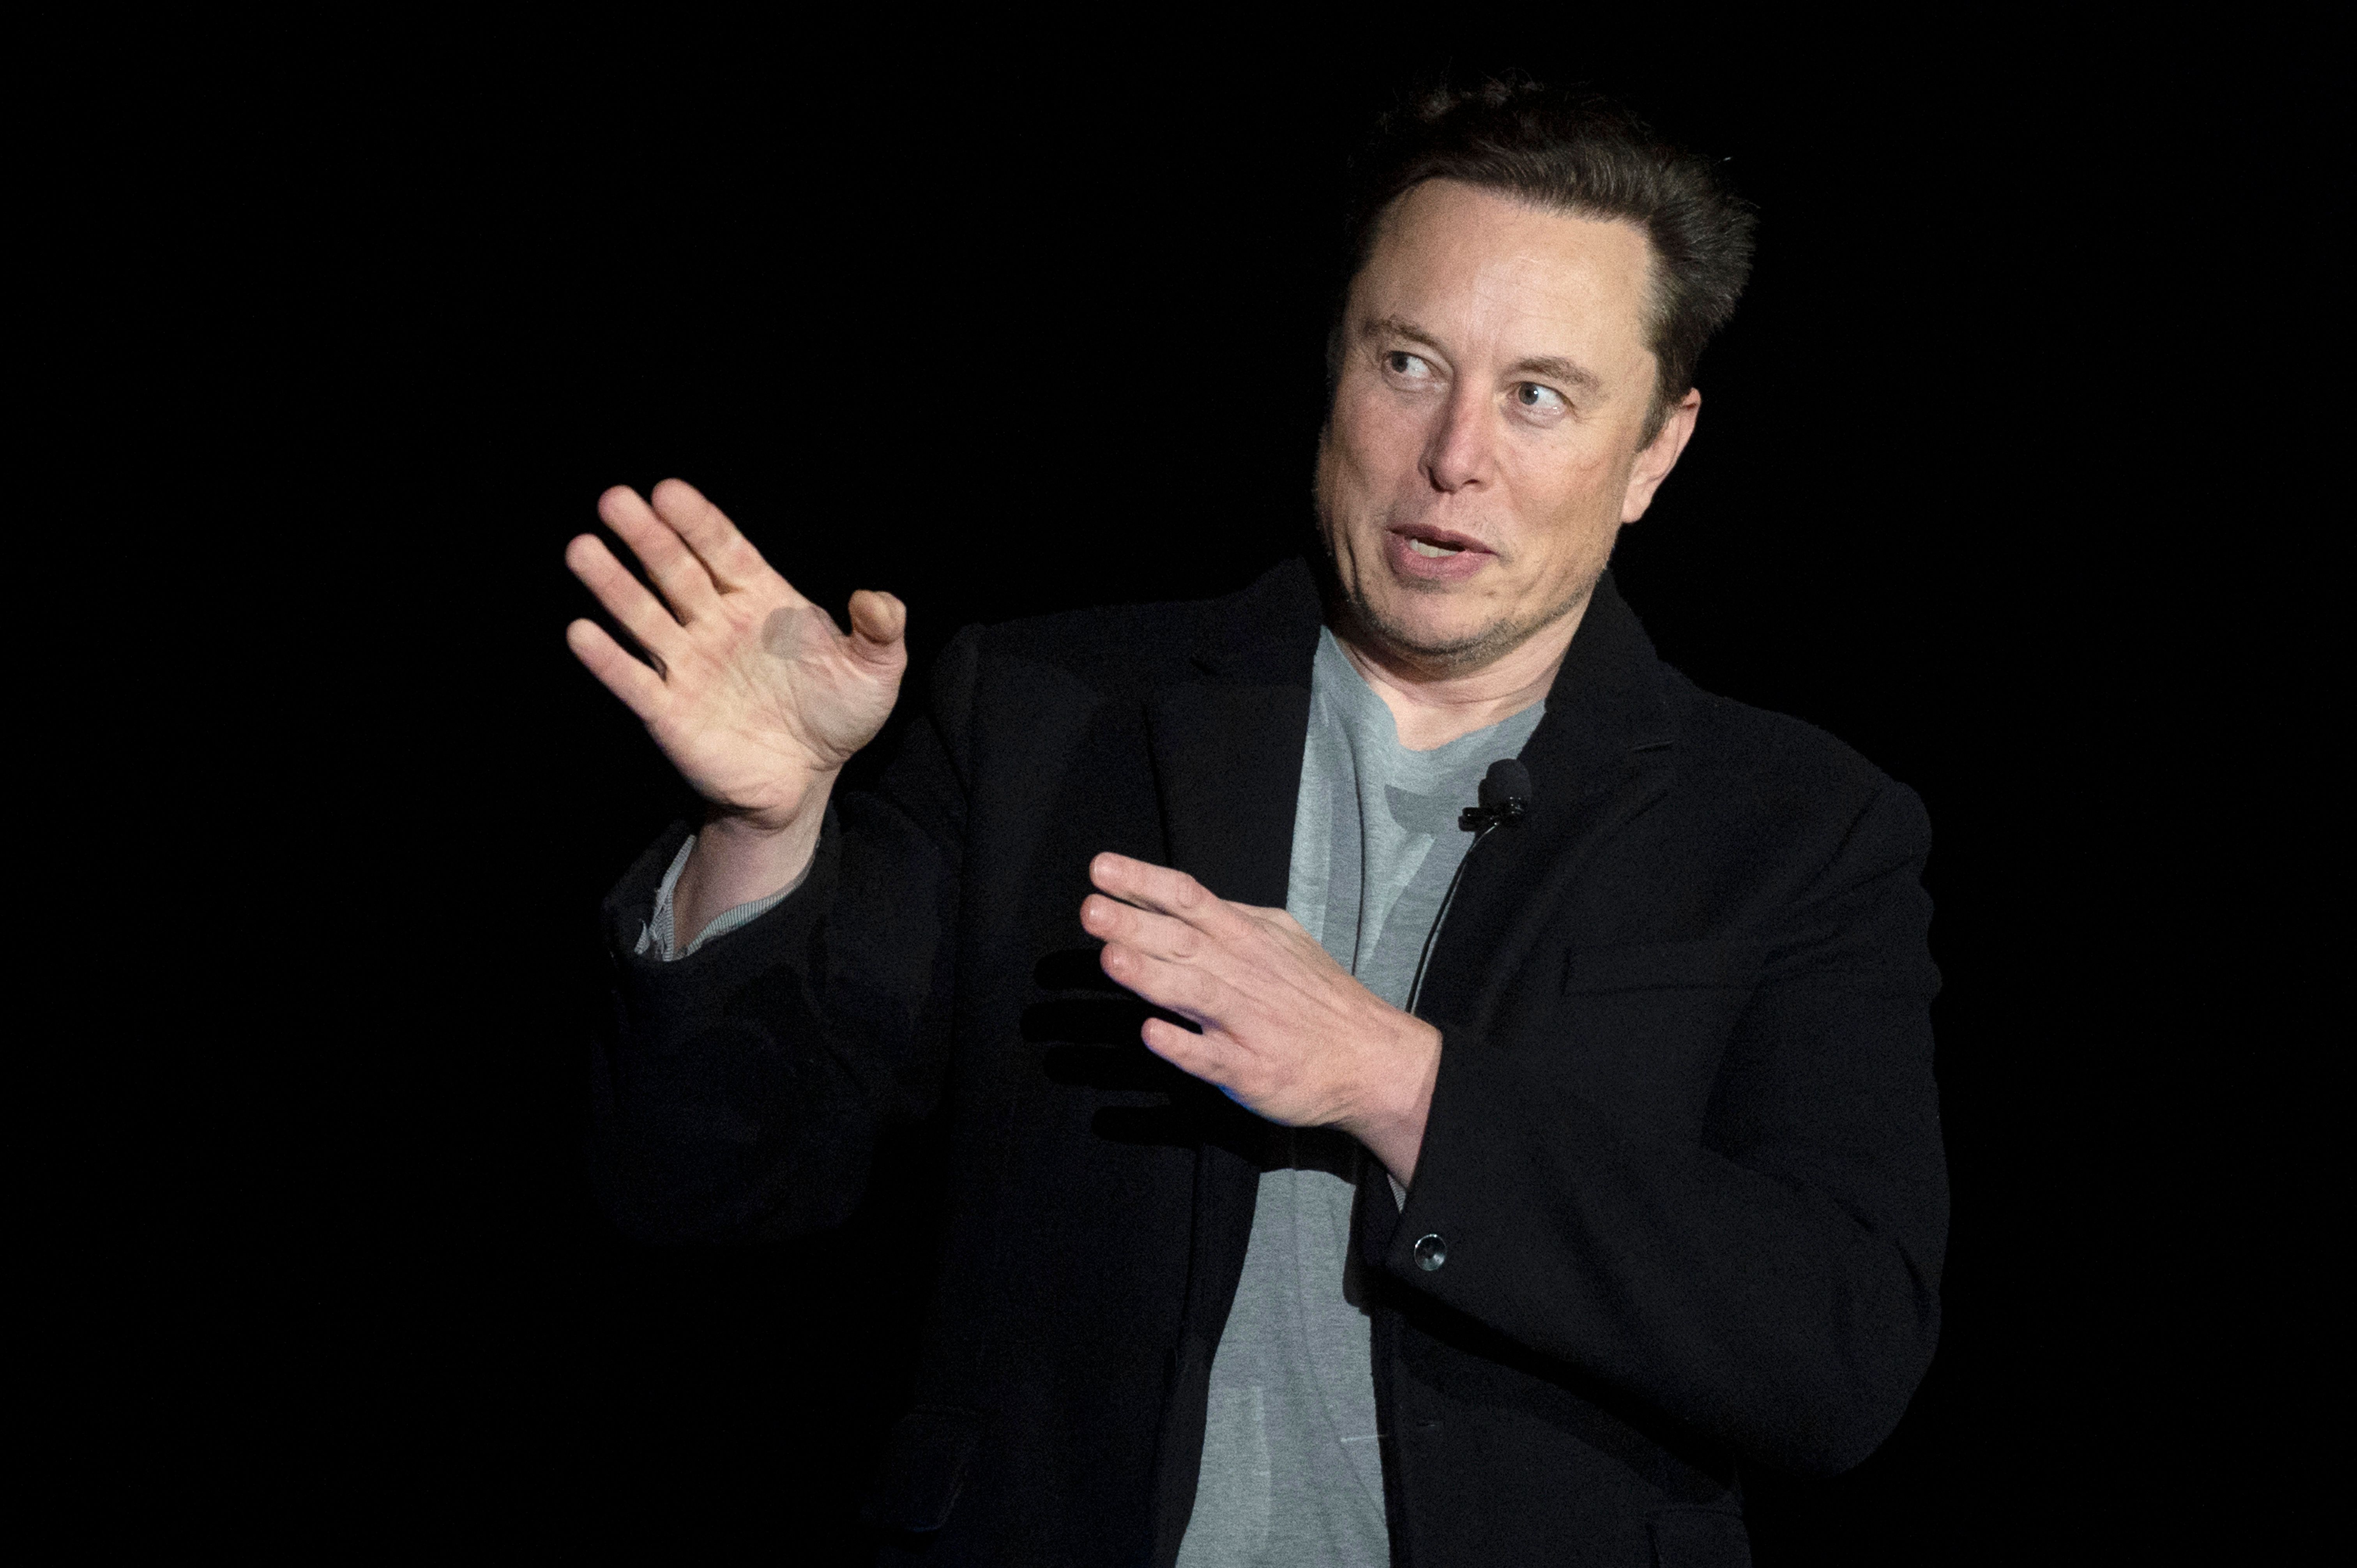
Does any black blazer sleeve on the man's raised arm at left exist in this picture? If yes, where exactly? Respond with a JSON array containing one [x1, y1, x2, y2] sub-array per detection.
[[592, 627, 981, 1240]]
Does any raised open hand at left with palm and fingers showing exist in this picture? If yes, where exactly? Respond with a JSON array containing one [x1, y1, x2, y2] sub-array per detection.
[[566, 479, 907, 943]]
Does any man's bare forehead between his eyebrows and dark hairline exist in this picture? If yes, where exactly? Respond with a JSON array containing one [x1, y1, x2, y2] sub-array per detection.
[[1351, 179, 1652, 351]]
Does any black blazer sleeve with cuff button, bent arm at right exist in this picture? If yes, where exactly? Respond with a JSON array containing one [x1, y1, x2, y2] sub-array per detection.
[[1369, 785, 1947, 1474]]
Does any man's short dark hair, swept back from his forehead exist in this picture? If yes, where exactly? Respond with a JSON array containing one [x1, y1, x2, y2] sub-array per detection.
[[1327, 78, 1756, 441]]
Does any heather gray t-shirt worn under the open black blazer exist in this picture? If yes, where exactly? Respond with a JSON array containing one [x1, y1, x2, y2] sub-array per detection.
[[1178, 632, 1546, 1568]]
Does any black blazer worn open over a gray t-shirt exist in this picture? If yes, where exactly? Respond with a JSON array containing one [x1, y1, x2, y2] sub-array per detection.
[[596, 561, 1947, 1568]]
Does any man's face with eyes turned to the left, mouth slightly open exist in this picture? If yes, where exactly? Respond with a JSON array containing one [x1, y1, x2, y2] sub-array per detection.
[[1318, 179, 1700, 675]]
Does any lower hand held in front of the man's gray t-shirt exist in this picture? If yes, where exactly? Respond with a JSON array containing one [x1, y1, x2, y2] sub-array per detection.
[[1080, 854, 1440, 1186]]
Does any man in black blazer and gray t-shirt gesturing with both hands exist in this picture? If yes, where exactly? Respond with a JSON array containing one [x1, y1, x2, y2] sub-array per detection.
[[568, 87, 1945, 1568]]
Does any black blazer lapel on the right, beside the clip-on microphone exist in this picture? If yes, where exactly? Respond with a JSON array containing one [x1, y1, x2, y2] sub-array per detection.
[[1417, 573, 1676, 1030]]
